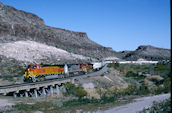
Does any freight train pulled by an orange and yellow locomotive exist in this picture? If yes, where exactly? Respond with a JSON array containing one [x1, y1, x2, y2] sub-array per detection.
[[24, 62, 104, 82]]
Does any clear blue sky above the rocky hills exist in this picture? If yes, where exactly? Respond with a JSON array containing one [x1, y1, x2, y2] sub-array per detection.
[[0, 0, 171, 51]]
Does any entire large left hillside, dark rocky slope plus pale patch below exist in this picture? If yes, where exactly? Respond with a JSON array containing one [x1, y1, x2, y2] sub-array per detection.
[[0, 3, 118, 75]]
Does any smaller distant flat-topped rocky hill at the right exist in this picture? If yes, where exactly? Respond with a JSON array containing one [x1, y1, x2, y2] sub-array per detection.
[[121, 45, 171, 60]]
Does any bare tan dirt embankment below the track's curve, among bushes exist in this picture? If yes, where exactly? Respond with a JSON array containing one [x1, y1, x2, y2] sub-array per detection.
[[76, 68, 128, 98]]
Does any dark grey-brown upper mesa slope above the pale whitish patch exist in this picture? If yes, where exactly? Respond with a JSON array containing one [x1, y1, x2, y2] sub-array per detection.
[[0, 4, 117, 58]]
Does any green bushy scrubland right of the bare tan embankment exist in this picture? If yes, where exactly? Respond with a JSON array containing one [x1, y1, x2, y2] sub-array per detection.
[[108, 63, 171, 95]]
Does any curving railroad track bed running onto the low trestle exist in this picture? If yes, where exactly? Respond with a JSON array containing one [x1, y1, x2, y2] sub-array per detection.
[[0, 64, 107, 95]]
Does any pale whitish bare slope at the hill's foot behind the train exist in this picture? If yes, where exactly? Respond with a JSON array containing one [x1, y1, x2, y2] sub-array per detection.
[[0, 41, 89, 64]]
